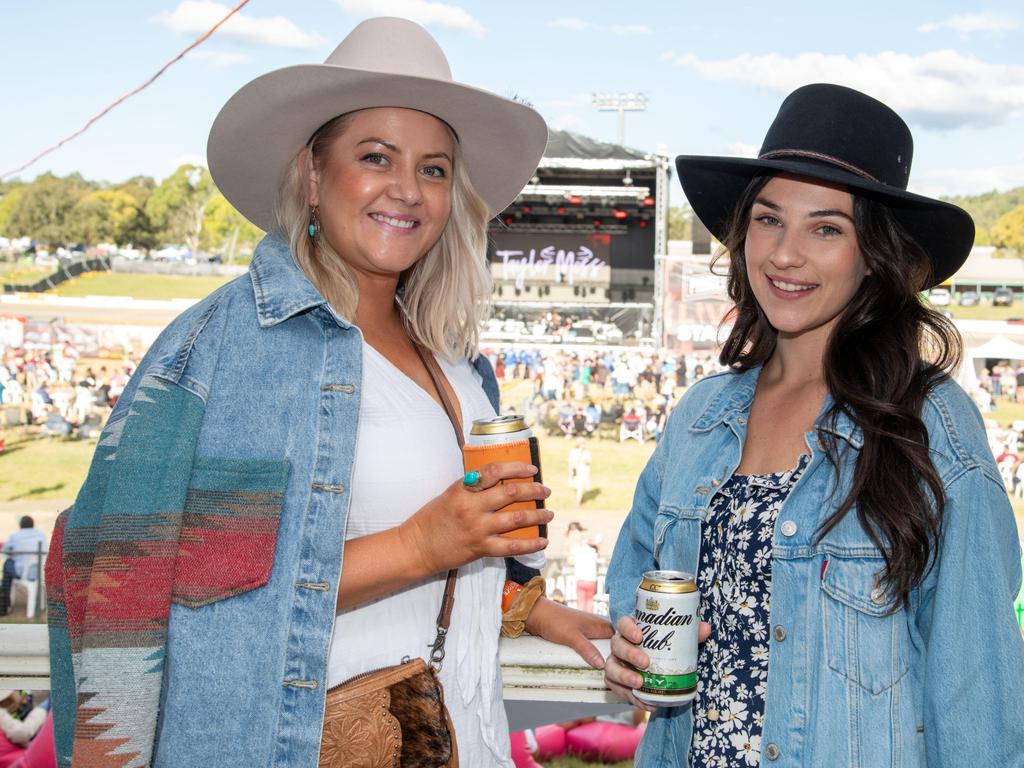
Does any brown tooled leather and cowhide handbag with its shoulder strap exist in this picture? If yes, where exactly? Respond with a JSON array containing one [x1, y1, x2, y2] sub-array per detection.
[[318, 344, 463, 768]]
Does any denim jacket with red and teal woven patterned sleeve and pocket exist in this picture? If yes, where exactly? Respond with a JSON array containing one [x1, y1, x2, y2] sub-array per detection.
[[47, 236, 498, 768]]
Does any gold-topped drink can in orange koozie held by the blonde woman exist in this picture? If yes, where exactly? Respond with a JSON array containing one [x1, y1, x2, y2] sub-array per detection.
[[462, 416, 548, 539]]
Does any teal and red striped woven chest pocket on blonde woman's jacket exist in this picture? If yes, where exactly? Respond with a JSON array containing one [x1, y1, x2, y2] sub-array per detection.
[[172, 458, 288, 608]]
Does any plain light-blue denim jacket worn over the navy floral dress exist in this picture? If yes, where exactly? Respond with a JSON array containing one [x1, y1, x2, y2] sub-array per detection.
[[607, 369, 1024, 768]]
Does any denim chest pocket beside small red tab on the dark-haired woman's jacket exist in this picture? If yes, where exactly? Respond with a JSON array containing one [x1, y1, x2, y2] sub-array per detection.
[[821, 557, 909, 694]]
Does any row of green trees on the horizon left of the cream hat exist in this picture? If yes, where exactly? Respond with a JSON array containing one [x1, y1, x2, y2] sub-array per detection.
[[0, 164, 263, 261]]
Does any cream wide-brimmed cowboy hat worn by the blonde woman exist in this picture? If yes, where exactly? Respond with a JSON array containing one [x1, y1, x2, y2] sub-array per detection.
[[207, 18, 548, 230]]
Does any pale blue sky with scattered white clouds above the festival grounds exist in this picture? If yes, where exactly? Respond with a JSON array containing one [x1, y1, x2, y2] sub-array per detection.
[[0, 0, 1024, 201]]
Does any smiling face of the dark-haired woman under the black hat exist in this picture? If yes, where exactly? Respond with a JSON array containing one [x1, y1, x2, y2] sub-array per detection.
[[744, 175, 869, 344]]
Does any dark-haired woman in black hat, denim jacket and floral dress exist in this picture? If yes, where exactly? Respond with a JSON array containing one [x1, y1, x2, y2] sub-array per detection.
[[605, 85, 1024, 768]]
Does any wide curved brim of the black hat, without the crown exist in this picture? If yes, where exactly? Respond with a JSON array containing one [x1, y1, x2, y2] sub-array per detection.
[[676, 155, 974, 286]]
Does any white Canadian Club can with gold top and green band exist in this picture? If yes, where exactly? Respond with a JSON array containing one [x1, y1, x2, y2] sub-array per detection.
[[633, 570, 700, 707]]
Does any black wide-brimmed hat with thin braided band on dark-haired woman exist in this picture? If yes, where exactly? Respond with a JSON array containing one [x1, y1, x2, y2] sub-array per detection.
[[676, 83, 974, 286]]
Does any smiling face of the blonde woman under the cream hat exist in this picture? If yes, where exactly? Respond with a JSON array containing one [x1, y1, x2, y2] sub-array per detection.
[[308, 108, 455, 280]]
